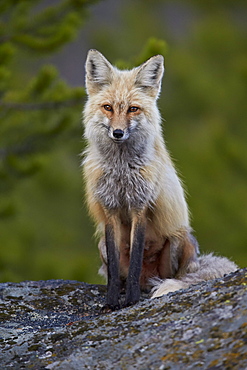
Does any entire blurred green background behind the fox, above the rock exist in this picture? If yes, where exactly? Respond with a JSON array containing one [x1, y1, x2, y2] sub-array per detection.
[[0, 0, 247, 283]]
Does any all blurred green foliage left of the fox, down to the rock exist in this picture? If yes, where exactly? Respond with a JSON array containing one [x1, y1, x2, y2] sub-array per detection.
[[0, 0, 96, 281]]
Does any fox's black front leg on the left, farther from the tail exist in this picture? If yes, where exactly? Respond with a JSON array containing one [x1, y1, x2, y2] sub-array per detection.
[[104, 224, 120, 312]]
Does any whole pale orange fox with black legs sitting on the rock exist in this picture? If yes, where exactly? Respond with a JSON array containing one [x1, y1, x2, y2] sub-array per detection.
[[83, 49, 238, 312]]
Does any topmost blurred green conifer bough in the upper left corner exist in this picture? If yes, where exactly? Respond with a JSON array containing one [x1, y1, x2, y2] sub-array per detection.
[[0, 0, 92, 53]]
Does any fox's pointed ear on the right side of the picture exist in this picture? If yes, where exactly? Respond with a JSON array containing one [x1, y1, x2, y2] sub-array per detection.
[[136, 55, 164, 97]]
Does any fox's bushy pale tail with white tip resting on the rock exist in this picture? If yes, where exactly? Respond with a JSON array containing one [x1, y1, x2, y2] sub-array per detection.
[[151, 253, 238, 298]]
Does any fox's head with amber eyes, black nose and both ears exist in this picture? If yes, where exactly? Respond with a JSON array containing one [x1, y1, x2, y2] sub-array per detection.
[[84, 49, 164, 144]]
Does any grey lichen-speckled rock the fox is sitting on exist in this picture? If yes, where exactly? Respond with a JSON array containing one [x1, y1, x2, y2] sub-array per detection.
[[0, 269, 247, 370]]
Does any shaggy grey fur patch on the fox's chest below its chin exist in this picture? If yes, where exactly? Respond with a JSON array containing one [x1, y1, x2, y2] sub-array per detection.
[[94, 142, 155, 212]]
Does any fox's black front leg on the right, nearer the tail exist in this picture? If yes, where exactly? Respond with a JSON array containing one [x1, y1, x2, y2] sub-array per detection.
[[125, 223, 145, 306]]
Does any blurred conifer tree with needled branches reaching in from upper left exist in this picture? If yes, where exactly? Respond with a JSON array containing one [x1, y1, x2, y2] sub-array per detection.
[[0, 0, 97, 217]]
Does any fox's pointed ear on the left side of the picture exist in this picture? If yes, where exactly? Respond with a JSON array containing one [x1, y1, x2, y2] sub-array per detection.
[[85, 49, 113, 95]]
